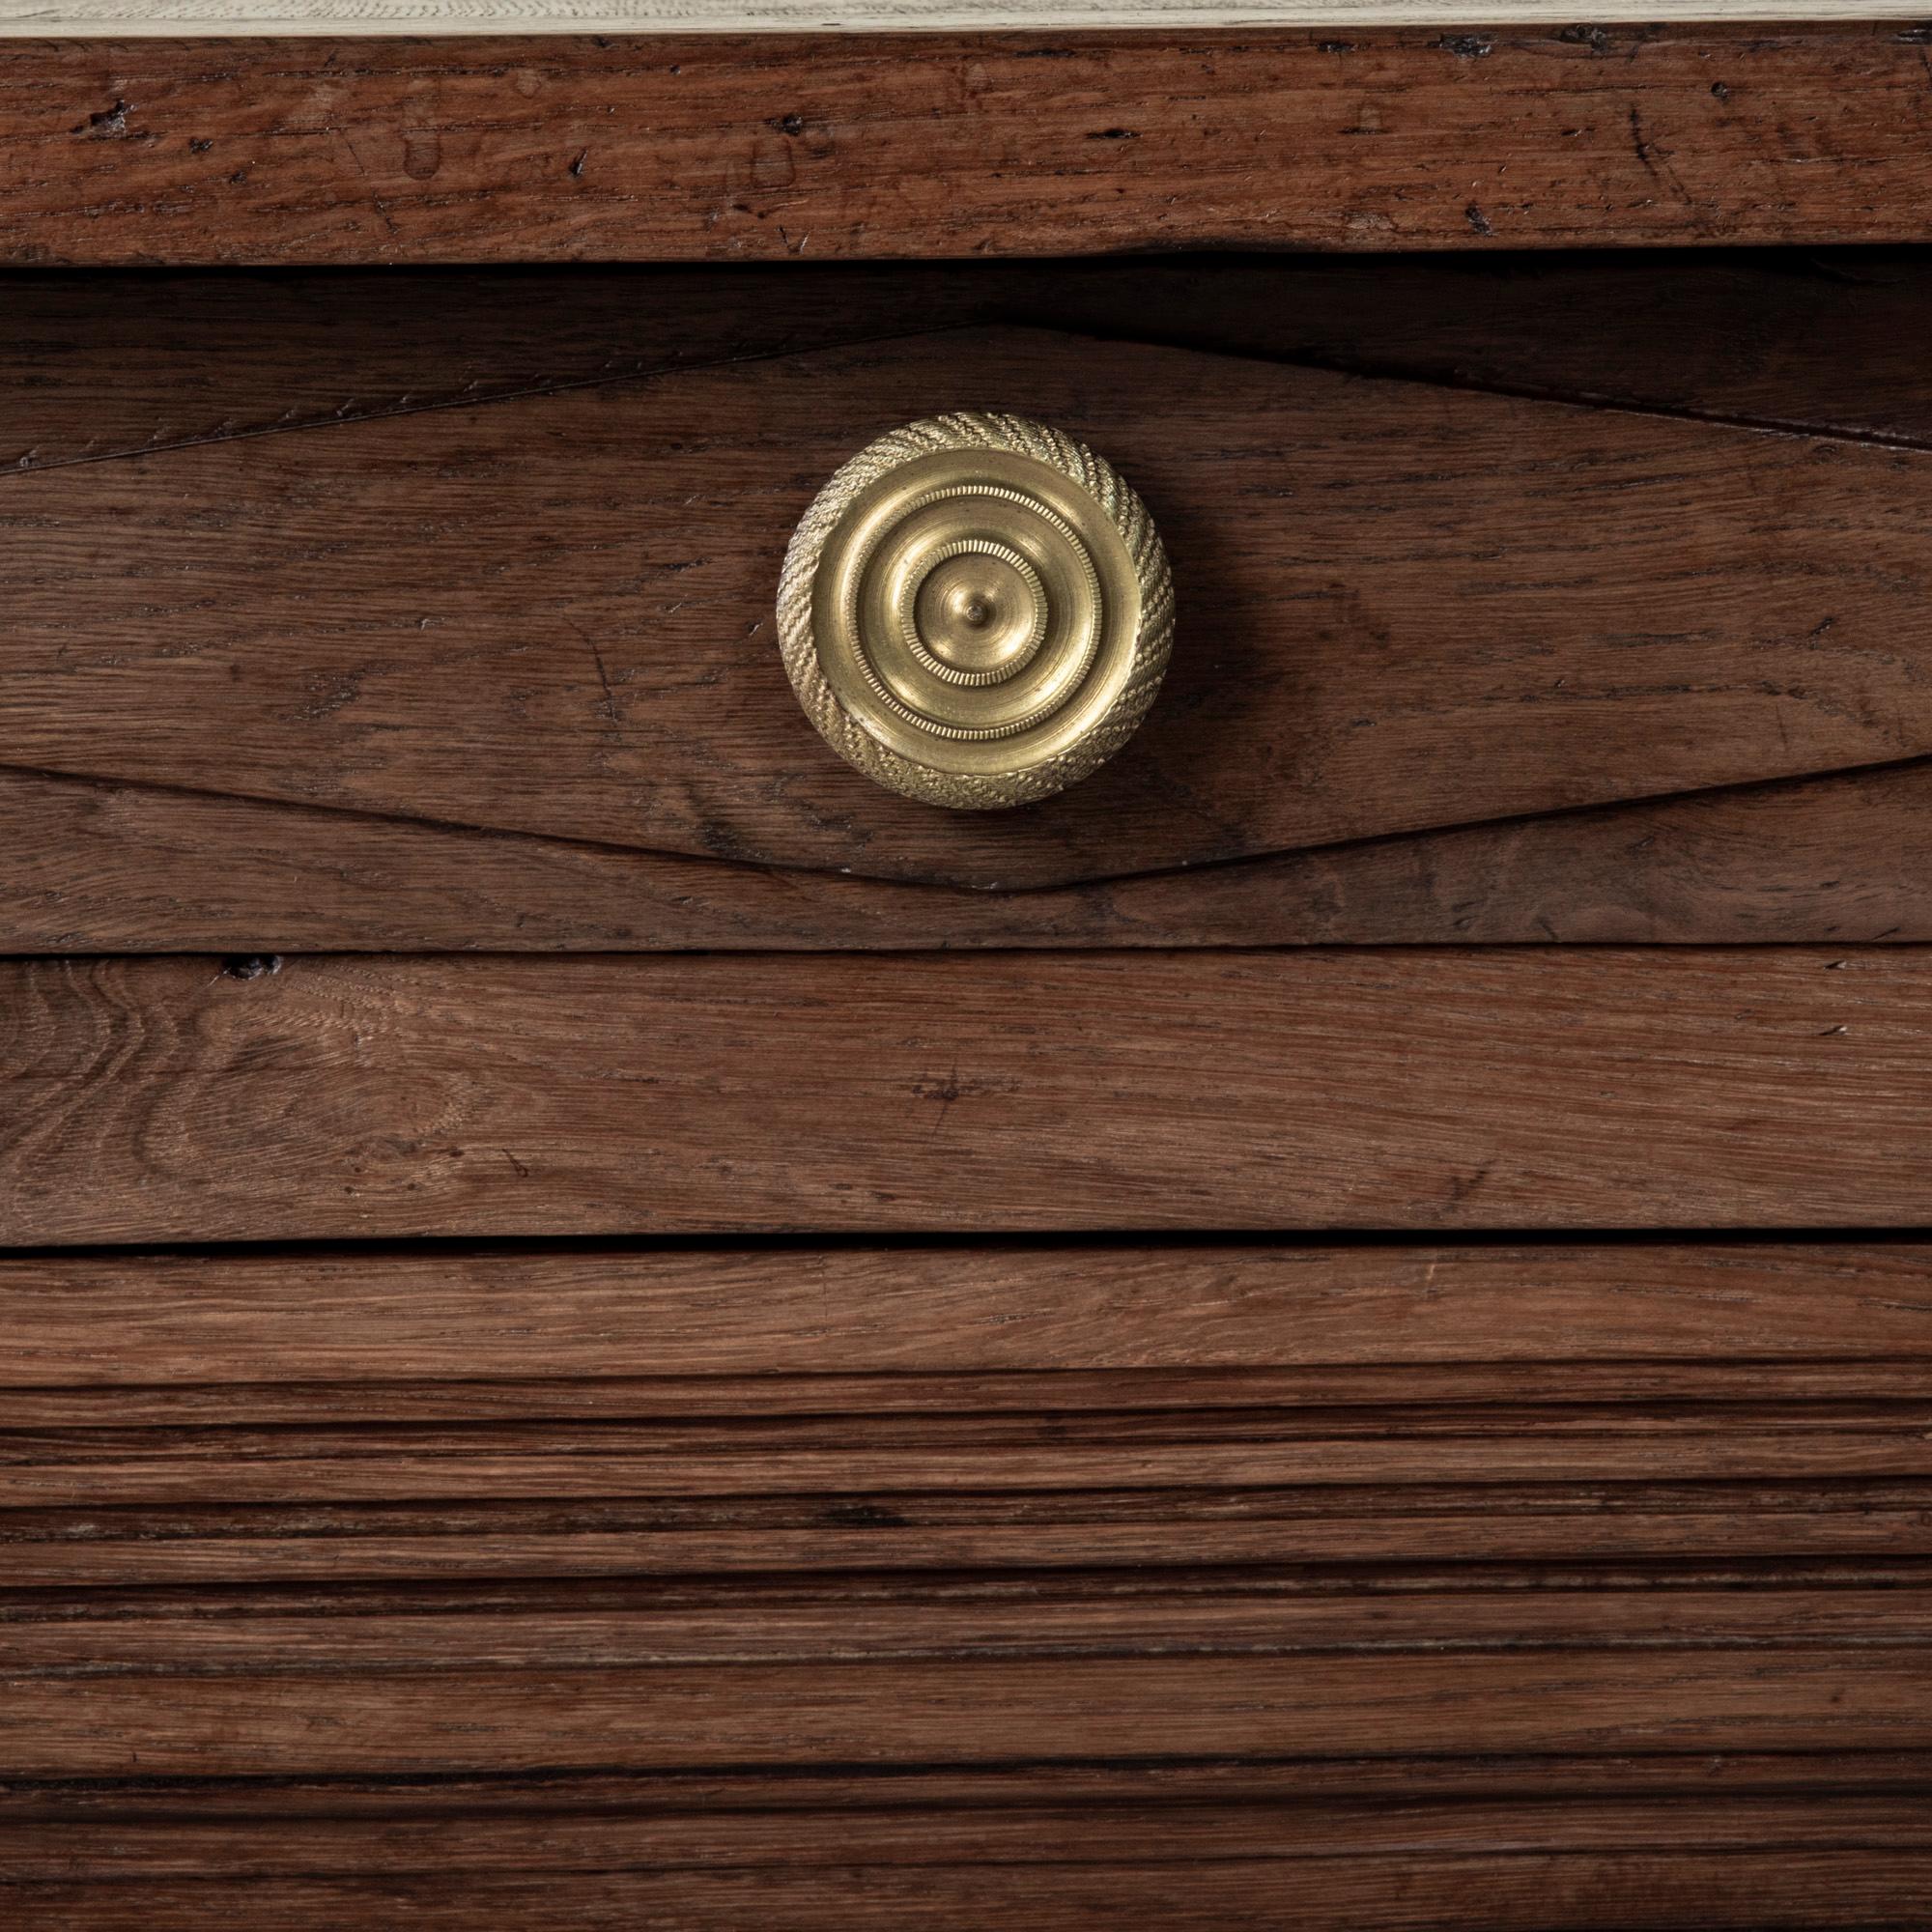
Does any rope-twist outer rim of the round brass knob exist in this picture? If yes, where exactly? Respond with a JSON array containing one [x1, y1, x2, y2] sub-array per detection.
[[779, 412, 1175, 811]]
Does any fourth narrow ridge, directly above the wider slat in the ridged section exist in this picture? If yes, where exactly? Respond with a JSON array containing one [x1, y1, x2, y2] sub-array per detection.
[[22, 1584, 1932, 1677]]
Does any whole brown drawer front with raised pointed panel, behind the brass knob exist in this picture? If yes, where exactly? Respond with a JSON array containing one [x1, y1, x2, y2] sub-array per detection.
[[11, 257, 1932, 951]]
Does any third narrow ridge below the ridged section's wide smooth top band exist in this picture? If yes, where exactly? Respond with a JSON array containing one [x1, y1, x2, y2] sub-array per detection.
[[14, 1478, 1932, 1592]]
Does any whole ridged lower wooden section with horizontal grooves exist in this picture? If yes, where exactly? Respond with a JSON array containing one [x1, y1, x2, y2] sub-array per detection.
[[0, 1242, 1932, 1928]]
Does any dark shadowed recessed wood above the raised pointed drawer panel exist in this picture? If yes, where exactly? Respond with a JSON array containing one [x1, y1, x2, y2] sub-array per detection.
[[18, 247, 1932, 469]]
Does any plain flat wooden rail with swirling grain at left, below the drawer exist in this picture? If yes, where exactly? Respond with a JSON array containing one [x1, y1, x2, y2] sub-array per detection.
[[11, 947, 1932, 1242]]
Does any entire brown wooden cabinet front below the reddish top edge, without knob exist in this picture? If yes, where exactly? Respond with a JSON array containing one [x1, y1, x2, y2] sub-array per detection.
[[11, 245, 1932, 1932]]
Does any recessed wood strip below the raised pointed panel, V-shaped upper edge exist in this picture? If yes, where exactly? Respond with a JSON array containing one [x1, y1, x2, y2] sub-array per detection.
[[18, 763, 1932, 958]]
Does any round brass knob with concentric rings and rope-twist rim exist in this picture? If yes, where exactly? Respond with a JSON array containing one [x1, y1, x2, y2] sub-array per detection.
[[779, 415, 1175, 811]]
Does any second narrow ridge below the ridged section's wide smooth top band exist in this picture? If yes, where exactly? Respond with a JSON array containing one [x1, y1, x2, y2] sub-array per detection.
[[22, 1403, 1932, 1509]]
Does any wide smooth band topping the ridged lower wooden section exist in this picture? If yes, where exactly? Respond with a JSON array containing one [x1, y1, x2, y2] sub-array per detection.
[[14, 1242, 1932, 1383]]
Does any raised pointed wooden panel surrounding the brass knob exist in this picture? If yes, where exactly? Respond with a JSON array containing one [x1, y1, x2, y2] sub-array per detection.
[[11, 330, 1932, 887]]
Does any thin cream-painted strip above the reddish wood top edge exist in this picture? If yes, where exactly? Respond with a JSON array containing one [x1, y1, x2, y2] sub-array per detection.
[[0, 0, 1909, 39]]
